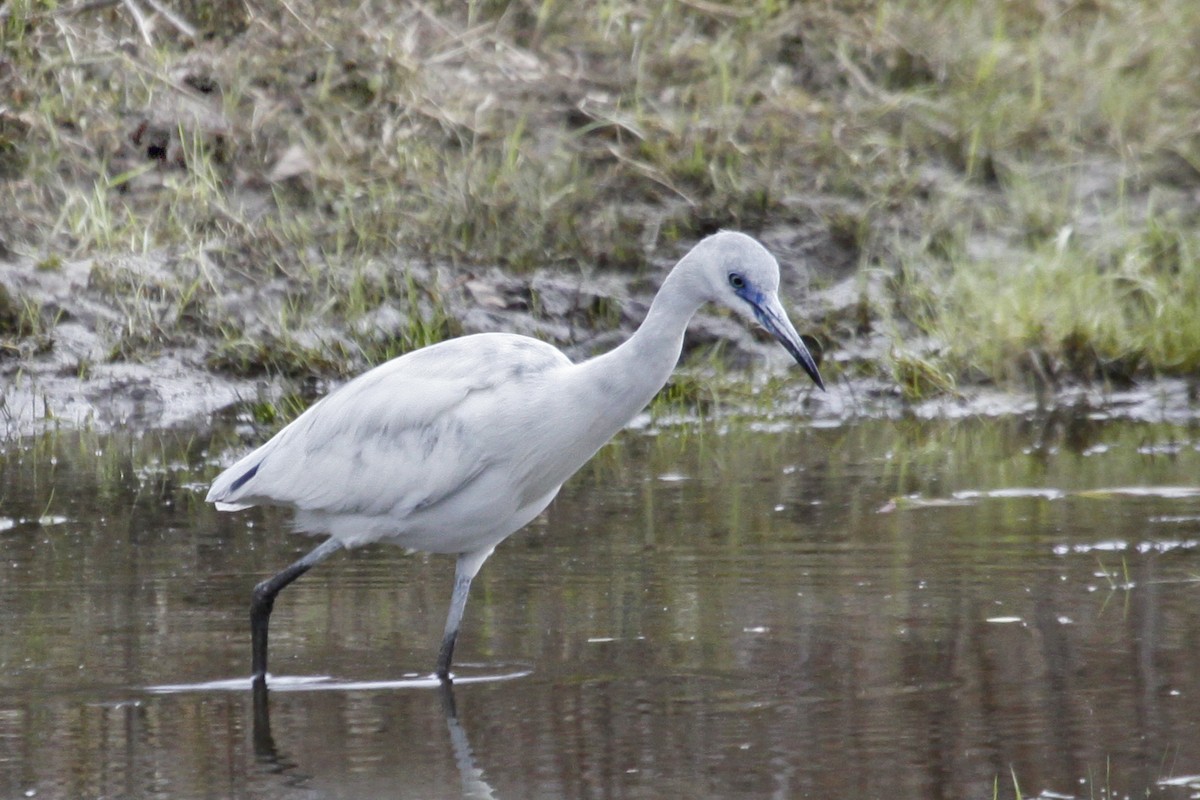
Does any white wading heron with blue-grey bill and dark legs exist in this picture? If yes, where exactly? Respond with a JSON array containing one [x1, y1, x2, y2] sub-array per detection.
[[208, 231, 824, 685]]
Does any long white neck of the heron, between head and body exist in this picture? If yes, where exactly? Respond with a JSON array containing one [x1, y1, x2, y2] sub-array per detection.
[[577, 264, 701, 424]]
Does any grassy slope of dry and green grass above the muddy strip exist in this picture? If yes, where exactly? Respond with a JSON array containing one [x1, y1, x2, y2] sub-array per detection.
[[0, 0, 1200, 402]]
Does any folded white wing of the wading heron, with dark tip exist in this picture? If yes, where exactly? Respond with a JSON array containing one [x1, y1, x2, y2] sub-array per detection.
[[208, 333, 570, 519]]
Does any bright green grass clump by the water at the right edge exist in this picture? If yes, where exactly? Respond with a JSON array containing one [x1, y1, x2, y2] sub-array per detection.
[[898, 200, 1200, 386]]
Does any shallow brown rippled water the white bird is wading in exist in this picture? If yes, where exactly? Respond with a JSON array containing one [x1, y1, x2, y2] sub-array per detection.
[[0, 416, 1200, 799]]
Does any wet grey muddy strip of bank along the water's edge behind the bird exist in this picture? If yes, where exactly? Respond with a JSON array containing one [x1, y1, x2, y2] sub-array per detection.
[[0, 245, 1196, 439]]
